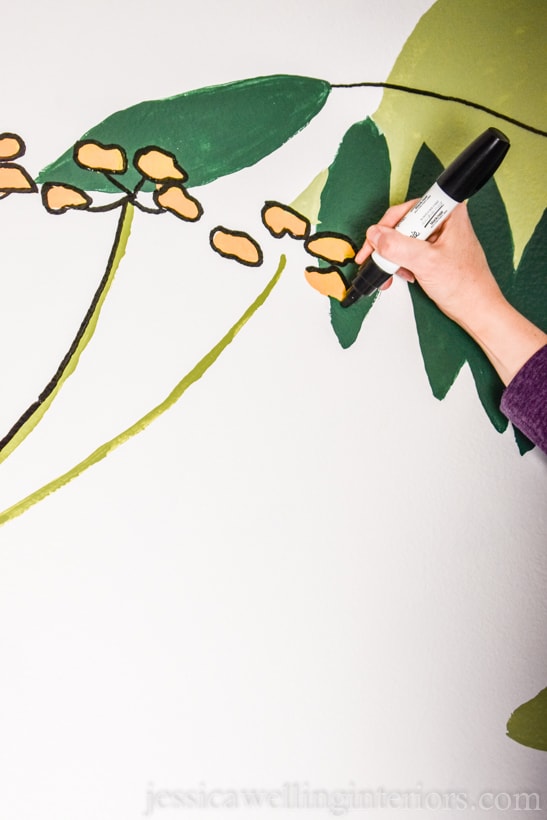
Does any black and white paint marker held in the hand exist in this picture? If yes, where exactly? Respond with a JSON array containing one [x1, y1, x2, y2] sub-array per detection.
[[341, 128, 510, 307]]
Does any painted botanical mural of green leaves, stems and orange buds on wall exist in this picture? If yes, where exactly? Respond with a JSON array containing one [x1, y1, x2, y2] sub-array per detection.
[[0, 0, 547, 749]]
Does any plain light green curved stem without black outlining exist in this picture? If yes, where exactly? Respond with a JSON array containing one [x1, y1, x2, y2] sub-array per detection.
[[0, 255, 286, 526]]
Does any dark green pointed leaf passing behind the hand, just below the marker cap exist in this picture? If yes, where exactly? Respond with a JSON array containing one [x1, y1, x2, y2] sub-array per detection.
[[407, 144, 467, 399]]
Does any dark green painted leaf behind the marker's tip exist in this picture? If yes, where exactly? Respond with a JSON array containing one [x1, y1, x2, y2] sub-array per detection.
[[319, 118, 391, 348]]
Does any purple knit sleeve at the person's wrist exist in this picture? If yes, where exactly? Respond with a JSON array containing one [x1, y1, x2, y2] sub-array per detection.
[[501, 345, 547, 453]]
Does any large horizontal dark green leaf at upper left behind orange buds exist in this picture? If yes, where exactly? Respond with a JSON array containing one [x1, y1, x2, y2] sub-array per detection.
[[38, 75, 331, 193]]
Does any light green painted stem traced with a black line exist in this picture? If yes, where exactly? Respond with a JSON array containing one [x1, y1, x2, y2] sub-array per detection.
[[0, 202, 134, 464]]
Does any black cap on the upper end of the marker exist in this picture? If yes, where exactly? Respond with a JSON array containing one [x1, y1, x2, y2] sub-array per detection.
[[437, 128, 510, 202]]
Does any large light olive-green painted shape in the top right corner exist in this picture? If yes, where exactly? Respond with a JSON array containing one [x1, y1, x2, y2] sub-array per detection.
[[374, 0, 547, 261]]
